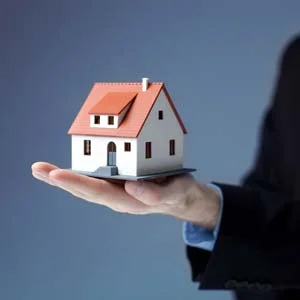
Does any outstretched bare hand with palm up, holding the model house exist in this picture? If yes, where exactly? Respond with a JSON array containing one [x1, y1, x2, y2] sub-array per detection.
[[32, 162, 219, 227]]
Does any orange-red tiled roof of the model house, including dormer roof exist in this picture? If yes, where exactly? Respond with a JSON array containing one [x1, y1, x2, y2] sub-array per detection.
[[68, 82, 187, 138]]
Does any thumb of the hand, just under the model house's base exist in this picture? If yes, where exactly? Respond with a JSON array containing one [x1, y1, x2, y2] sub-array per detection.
[[125, 181, 163, 206]]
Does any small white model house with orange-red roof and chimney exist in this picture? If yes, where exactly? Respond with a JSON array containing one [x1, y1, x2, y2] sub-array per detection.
[[68, 78, 190, 176]]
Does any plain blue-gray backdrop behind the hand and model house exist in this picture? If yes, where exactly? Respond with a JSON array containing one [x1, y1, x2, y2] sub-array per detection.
[[0, 0, 300, 300]]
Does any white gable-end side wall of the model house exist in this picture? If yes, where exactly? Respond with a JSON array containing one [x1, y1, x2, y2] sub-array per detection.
[[137, 91, 184, 175]]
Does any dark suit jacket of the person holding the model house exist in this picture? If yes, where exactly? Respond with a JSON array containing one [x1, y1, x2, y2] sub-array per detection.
[[186, 37, 300, 299]]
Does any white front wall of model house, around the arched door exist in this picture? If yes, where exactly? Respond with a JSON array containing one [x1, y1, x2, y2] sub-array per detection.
[[71, 135, 137, 176]]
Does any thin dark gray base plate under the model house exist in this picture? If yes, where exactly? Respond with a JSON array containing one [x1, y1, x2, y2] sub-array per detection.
[[68, 168, 197, 181]]
